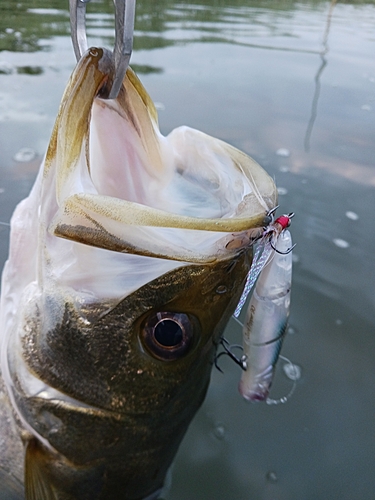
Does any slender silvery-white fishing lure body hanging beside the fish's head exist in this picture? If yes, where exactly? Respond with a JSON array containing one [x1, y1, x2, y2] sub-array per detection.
[[239, 229, 292, 401]]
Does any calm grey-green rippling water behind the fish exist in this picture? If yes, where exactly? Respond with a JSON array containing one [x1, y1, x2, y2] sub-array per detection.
[[0, 0, 375, 500]]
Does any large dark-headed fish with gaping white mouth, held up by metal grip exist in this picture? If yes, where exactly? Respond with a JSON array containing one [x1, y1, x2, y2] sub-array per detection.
[[0, 47, 277, 500]]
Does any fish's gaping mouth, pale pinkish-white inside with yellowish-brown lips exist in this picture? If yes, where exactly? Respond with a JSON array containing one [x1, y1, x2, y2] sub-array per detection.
[[42, 48, 277, 263]]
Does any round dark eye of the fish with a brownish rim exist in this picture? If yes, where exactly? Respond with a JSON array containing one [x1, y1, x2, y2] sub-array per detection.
[[141, 312, 193, 361]]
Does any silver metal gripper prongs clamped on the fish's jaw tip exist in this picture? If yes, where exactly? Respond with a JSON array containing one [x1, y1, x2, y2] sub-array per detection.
[[69, 0, 136, 99]]
